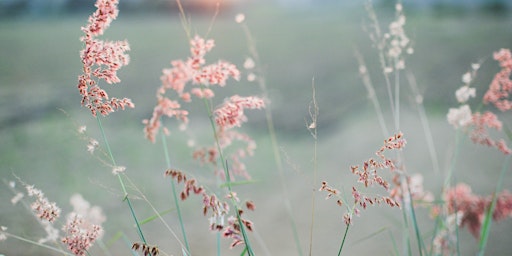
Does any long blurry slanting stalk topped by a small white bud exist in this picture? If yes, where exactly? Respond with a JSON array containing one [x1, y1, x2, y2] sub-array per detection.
[[241, 20, 303, 256]]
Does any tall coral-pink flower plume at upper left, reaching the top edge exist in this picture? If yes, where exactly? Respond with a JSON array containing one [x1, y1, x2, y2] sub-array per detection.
[[78, 0, 135, 116]]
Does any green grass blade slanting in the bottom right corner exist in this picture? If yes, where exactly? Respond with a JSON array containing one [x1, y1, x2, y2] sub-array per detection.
[[478, 155, 511, 256]]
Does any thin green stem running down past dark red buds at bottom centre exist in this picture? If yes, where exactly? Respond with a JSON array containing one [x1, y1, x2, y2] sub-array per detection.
[[203, 98, 254, 256]]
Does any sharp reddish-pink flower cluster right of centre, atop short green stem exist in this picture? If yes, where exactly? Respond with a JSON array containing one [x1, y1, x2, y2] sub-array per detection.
[[319, 133, 406, 225]]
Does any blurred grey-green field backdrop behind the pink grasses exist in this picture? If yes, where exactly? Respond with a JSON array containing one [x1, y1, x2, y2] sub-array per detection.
[[0, 0, 512, 255]]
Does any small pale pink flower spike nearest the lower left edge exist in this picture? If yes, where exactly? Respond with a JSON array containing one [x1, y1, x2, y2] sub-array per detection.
[[25, 185, 61, 222]]
